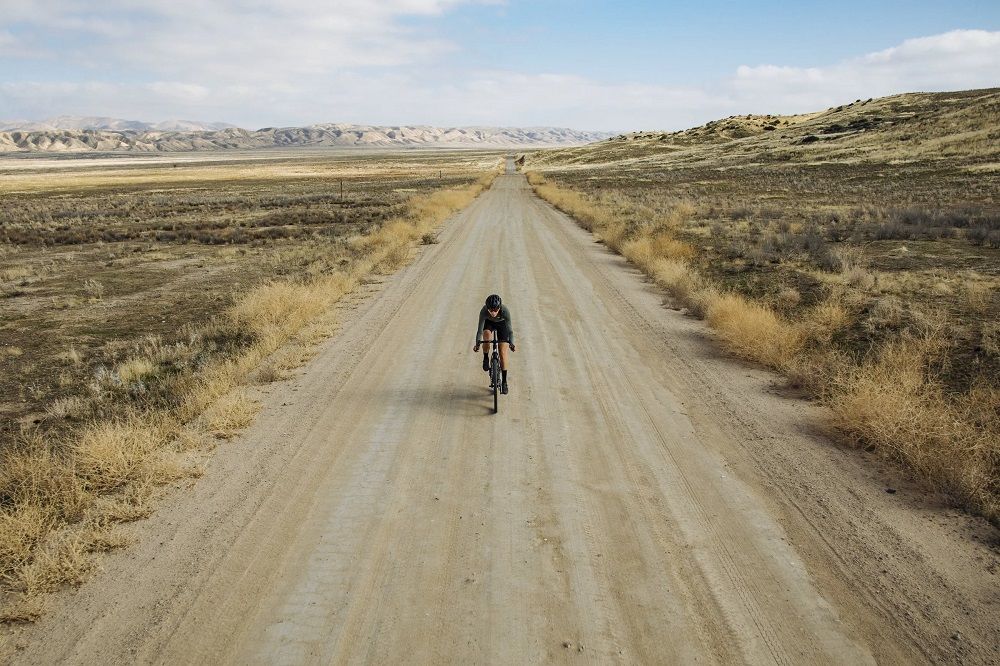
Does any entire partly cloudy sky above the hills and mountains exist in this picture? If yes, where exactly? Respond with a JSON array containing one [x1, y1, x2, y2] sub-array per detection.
[[0, 0, 1000, 131]]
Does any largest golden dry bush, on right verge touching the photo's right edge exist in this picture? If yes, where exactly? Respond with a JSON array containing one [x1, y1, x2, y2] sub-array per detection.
[[828, 336, 1000, 520]]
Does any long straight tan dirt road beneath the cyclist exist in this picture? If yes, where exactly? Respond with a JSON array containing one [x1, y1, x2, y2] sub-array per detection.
[[9, 163, 1000, 664]]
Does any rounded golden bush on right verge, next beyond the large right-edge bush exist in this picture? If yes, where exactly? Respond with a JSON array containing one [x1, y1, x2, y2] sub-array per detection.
[[707, 293, 804, 368]]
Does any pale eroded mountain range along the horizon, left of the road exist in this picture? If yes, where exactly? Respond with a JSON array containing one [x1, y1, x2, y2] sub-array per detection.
[[0, 116, 614, 153]]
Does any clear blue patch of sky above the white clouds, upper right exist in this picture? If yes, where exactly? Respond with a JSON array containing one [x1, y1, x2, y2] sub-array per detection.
[[440, 0, 1000, 83]]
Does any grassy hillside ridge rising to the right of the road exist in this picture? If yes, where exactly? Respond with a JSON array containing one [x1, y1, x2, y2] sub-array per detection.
[[534, 88, 1000, 165]]
